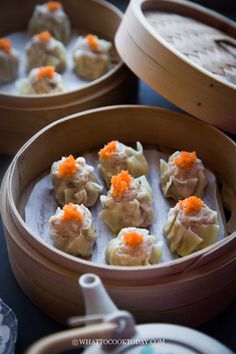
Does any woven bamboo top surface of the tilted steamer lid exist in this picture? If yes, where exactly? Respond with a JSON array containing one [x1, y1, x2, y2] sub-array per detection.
[[143, 9, 236, 85]]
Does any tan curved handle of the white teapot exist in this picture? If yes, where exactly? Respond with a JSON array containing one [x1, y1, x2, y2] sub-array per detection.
[[25, 322, 118, 354]]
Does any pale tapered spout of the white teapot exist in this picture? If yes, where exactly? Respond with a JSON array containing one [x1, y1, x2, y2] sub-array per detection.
[[79, 273, 118, 316]]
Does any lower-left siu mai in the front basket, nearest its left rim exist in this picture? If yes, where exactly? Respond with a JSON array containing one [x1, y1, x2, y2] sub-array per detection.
[[49, 203, 96, 257]]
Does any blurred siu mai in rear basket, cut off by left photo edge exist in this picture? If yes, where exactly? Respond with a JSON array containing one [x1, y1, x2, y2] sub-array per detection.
[[0, 38, 19, 85]]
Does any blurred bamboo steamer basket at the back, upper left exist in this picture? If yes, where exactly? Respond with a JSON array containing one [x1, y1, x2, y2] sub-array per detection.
[[0, 0, 135, 153]]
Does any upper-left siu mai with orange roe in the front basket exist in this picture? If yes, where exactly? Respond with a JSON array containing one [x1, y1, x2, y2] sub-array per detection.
[[51, 155, 103, 207]]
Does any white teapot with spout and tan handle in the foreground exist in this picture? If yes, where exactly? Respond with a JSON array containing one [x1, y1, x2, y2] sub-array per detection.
[[26, 274, 234, 354]]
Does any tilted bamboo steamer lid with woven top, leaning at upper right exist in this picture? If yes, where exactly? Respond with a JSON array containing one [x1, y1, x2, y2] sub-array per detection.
[[116, 0, 236, 133]]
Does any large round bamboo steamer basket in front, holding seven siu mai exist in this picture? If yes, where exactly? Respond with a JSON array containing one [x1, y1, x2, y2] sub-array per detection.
[[1, 106, 236, 325]]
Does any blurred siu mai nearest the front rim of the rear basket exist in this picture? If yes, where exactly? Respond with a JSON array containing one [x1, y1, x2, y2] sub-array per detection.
[[18, 66, 64, 95]]
